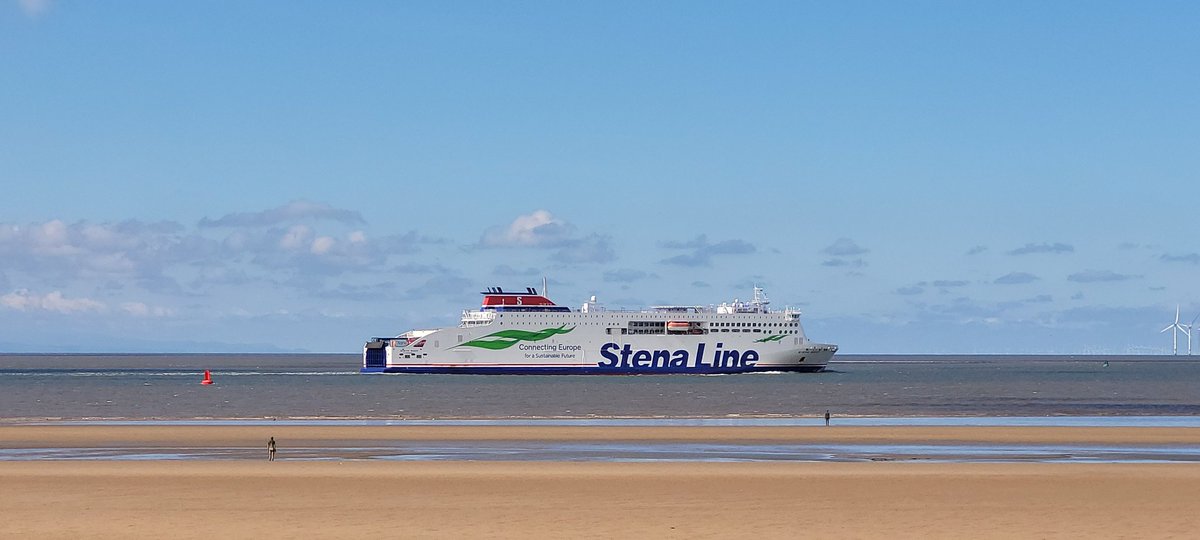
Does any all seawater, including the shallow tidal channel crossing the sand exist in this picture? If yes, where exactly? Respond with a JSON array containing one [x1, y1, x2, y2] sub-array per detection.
[[0, 354, 1200, 463]]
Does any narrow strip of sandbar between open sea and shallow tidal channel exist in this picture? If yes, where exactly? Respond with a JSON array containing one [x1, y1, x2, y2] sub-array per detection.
[[7, 425, 1200, 449]]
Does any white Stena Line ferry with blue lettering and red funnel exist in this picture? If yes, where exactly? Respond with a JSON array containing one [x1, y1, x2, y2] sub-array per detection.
[[361, 283, 838, 374]]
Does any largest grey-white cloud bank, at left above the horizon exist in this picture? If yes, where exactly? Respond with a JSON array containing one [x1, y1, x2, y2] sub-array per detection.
[[0, 203, 460, 318]]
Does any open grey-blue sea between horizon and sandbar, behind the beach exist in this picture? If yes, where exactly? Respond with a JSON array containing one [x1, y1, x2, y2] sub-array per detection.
[[0, 354, 1200, 421]]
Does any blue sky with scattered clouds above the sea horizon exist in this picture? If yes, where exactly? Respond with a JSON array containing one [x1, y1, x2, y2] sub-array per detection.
[[0, 0, 1200, 354]]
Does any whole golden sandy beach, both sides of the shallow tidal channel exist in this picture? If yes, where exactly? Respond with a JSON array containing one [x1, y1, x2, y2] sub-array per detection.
[[0, 426, 1200, 538]]
